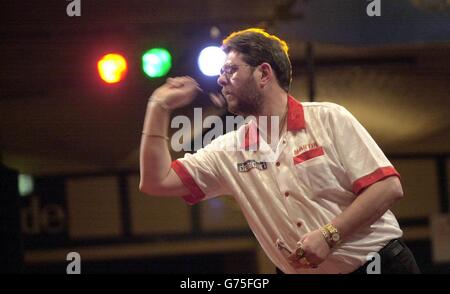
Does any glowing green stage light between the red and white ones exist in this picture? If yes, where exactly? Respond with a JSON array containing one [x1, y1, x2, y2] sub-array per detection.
[[142, 48, 172, 78]]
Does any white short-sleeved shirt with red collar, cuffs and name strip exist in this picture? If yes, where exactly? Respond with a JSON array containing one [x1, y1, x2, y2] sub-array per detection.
[[172, 96, 402, 273]]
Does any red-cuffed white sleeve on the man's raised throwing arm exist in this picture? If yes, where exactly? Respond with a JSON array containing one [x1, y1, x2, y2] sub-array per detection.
[[172, 141, 227, 205]]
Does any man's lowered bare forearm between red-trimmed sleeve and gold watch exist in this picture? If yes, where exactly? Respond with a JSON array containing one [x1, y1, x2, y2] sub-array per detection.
[[331, 177, 403, 239]]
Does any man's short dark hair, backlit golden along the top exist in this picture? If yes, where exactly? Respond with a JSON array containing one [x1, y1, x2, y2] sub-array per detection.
[[222, 28, 292, 92]]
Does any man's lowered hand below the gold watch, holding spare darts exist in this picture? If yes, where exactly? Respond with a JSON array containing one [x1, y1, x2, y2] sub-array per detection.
[[289, 230, 330, 268]]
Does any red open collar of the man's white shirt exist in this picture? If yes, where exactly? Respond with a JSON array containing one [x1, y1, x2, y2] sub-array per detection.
[[241, 95, 305, 150]]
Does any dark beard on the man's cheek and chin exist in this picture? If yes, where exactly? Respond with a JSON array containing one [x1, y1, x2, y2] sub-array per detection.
[[228, 78, 263, 116]]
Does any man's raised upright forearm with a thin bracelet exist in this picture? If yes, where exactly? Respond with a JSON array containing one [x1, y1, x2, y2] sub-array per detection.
[[139, 103, 172, 190]]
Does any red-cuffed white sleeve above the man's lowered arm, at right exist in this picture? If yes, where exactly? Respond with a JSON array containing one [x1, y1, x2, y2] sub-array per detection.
[[329, 105, 400, 195]]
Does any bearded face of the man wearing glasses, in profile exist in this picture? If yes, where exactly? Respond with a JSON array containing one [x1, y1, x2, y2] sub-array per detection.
[[217, 51, 262, 116]]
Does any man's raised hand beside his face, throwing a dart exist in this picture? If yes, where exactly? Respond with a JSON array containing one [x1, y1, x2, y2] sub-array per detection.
[[152, 76, 202, 110]]
